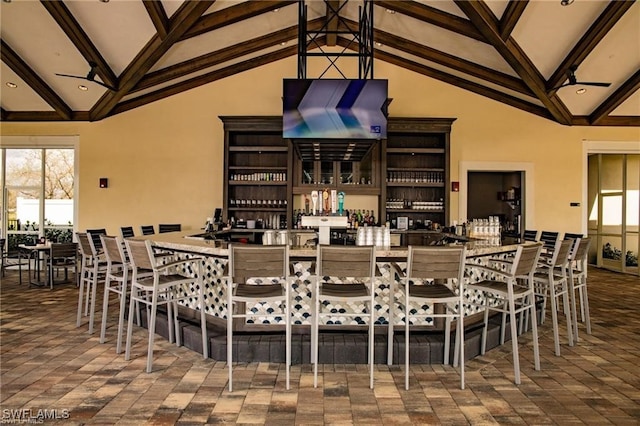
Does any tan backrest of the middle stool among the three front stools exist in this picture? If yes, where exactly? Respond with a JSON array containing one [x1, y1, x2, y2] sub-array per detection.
[[316, 245, 376, 281]]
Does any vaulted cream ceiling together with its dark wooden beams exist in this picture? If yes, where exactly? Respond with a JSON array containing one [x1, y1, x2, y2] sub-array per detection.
[[0, 0, 640, 126]]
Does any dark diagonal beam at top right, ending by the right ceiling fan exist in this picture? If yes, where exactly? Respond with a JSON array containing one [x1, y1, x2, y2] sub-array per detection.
[[546, 0, 634, 91]]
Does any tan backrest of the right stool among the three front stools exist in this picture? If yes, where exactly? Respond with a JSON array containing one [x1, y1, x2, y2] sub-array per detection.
[[407, 246, 466, 285]]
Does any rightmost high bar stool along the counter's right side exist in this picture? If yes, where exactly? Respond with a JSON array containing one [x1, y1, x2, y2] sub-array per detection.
[[569, 238, 591, 342]]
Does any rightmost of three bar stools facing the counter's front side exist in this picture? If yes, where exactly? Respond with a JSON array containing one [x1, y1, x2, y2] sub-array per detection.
[[401, 246, 466, 390]]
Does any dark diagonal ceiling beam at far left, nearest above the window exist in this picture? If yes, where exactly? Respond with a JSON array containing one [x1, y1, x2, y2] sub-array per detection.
[[0, 40, 72, 120]]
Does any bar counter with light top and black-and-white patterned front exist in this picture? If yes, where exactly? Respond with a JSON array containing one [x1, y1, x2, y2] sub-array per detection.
[[141, 230, 517, 331]]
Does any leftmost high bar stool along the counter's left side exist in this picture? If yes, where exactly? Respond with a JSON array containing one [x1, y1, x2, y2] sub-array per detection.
[[76, 232, 107, 334]]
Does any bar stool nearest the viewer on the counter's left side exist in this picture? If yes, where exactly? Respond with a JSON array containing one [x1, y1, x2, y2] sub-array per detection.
[[124, 239, 209, 373]]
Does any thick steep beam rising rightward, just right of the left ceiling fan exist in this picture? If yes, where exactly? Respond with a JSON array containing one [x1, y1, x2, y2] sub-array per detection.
[[89, 0, 214, 120]]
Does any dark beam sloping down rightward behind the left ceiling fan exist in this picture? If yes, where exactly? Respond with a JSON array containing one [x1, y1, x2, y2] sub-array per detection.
[[40, 0, 118, 87]]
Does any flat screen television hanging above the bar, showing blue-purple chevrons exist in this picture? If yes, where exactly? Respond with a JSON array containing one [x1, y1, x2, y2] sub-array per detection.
[[282, 79, 388, 139]]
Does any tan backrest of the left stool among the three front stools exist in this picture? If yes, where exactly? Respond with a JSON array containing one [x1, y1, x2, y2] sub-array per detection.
[[229, 244, 289, 284]]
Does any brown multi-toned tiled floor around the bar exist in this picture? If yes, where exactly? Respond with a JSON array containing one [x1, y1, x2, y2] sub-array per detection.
[[0, 269, 640, 425]]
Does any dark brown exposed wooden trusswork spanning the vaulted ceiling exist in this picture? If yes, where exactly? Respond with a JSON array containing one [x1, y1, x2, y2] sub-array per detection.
[[0, 0, 640, 126]]
